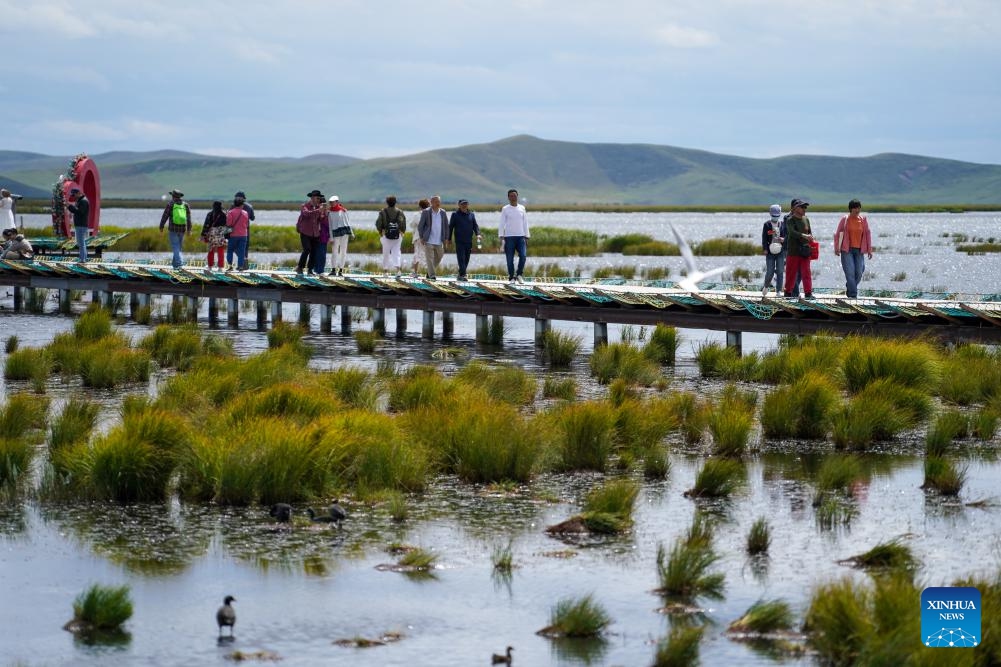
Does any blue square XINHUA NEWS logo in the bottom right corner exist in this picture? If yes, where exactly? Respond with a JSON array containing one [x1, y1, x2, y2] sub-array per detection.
[[921, 586, 980, 648]]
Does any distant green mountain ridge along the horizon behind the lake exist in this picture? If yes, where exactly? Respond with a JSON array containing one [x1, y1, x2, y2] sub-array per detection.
[[0, 135, 1001, 205]]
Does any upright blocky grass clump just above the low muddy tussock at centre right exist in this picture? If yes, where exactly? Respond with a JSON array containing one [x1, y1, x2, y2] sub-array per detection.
[[554, 401, 616, 472]]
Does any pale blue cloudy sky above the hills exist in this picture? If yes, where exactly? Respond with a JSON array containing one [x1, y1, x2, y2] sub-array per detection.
[[0, 0, 1001, 163]]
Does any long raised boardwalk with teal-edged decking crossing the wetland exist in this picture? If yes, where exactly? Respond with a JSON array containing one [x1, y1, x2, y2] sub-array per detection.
[[0, 255, 1001, 345]]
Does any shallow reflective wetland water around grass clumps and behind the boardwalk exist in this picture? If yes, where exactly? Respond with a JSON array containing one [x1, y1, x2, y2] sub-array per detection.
[[0, 208, 1001, 666]]
